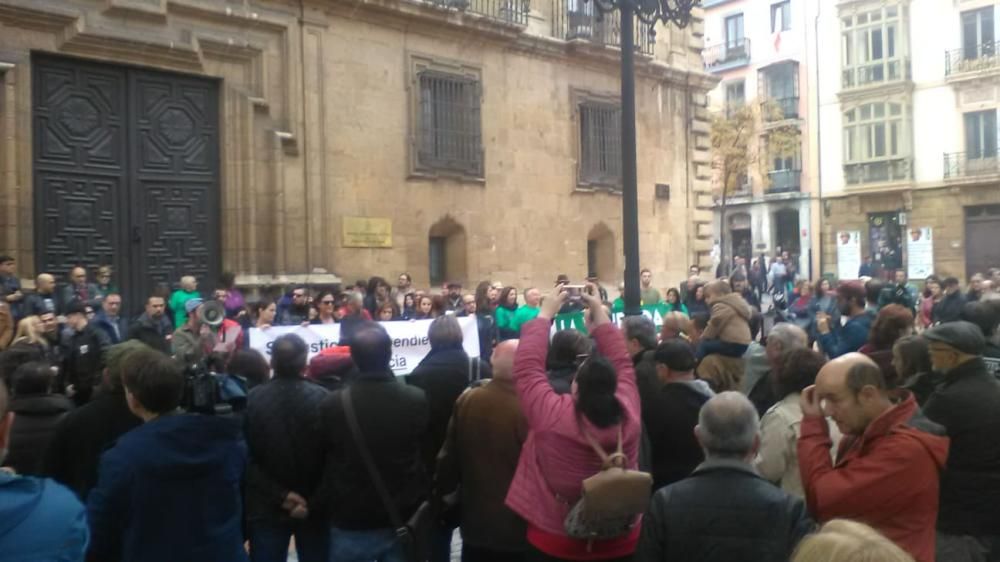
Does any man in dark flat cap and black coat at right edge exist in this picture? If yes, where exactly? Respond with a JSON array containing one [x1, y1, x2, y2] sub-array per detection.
[[923, 320, 1000, 560]]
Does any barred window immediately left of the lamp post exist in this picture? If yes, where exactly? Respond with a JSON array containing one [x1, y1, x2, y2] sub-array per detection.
[[579, 101, 622, 189]]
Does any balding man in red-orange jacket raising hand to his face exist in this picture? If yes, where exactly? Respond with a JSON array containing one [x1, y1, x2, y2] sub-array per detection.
[[798, 353, 948, 562]]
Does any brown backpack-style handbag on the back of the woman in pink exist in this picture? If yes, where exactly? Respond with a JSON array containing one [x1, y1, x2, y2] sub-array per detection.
[[563, 425, 653, 540]]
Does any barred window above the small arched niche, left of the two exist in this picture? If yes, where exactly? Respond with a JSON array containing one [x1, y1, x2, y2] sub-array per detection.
[[416, 70, 483, 177]]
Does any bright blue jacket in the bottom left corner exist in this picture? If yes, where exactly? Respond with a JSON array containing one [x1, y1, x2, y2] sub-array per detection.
[[0, 471, 90, 562]]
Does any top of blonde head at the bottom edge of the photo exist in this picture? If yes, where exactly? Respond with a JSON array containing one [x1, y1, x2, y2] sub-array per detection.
[[792, 519, 914, 562]]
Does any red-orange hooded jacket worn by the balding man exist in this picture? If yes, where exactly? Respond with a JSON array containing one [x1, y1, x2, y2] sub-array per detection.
[[798, 392, 948, 562]]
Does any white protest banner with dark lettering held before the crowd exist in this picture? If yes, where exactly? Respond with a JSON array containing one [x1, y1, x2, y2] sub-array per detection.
[[250, 317, 479, 376]]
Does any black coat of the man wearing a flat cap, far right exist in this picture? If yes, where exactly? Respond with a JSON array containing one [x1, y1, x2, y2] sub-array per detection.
[[924, 359, 1000, 536]]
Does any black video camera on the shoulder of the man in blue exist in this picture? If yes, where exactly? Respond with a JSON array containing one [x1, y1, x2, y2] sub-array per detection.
[[181, 354, 247, 416]]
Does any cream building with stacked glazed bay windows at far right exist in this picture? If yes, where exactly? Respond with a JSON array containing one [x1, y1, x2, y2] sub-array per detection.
[[810, 0, 1000, 280]]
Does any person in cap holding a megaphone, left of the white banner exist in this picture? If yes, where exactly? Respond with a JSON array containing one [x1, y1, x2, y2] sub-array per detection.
[[173, 298, 243, 365]]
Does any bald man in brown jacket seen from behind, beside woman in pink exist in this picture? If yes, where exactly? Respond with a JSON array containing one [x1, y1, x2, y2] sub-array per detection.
[[434, 340, 528, 562]]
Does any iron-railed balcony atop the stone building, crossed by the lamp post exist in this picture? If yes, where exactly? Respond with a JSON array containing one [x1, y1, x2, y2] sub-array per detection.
[[552, 0, 655, 56]]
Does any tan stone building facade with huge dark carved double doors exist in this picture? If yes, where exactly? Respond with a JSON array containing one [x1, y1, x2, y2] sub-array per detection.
[[0, 0, 715, 308]]
